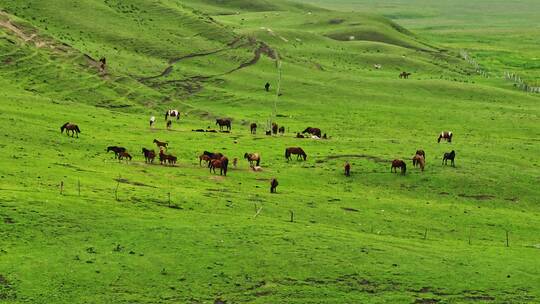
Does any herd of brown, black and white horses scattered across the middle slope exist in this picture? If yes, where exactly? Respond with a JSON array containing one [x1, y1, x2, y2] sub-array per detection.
[[60, 119, 456, 193]]
